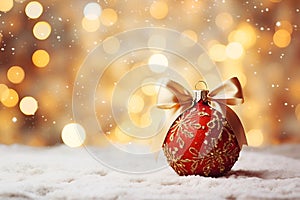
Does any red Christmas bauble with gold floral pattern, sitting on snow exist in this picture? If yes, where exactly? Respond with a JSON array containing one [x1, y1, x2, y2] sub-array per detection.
[[163, 99, 241, 177]]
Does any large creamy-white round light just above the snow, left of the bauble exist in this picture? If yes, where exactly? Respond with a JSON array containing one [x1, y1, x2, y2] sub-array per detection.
[[61, 123, 86, 147]]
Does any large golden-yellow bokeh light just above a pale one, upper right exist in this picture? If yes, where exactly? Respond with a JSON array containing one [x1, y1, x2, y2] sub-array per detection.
[[228, 23, 257, 48]]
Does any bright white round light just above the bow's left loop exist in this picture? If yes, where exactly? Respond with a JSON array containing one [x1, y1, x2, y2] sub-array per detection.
[[148, 54, 169, 73]]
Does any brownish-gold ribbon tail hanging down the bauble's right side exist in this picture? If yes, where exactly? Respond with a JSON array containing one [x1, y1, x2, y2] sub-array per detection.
[[223, 106, 248, 148]]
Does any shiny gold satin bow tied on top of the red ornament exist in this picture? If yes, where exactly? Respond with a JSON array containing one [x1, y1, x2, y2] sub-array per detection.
[[157, 77, 247, 148]]
